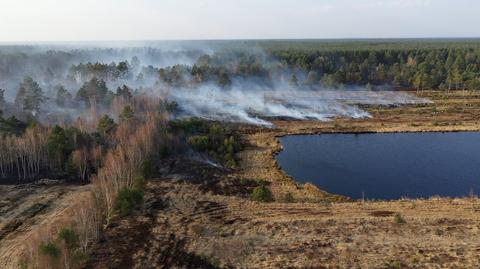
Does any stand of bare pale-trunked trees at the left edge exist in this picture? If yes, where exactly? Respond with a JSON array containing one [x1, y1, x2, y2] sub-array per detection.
[[0, 119, 102, 182]]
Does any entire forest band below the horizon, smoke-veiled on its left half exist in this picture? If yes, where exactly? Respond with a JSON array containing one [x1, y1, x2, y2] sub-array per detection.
[[0, 39, 480, 93]]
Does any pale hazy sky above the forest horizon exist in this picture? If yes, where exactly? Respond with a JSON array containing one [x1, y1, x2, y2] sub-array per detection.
[[0, 0, 480, 41]]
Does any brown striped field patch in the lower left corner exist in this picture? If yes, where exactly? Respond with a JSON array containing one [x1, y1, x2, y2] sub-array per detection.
[[0, 180, 89, 268]]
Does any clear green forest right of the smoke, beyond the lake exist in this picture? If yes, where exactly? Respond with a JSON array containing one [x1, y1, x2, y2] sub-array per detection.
[[273, 49, 480, 90]]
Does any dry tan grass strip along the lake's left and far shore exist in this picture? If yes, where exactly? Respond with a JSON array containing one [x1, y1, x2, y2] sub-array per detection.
[[239, 91, 480, 202]]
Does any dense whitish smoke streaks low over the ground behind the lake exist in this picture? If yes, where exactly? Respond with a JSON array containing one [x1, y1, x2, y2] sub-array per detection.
[[168, 85, 430, 126]]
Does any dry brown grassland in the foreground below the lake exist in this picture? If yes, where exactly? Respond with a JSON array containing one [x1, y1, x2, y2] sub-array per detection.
[[88, 179, 480, 268]]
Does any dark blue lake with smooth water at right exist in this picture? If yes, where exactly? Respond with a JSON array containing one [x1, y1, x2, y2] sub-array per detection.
[[277, 133, 480, 199]]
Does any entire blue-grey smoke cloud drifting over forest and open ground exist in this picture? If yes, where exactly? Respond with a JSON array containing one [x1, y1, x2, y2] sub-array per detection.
[[0, 42, 429, 126]]
